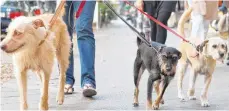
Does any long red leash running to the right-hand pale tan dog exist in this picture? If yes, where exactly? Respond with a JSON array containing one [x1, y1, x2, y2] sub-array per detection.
[[124, 0, 189, 45]]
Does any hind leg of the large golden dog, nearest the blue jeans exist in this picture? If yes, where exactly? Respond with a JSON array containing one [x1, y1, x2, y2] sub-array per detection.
[[56, 29, 71, 105]]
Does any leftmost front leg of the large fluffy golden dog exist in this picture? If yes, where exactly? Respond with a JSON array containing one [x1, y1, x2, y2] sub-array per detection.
[[16, 69, 28, 110]]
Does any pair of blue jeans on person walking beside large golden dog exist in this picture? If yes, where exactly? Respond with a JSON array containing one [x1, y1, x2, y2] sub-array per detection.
[[63, 1, 96, 88]]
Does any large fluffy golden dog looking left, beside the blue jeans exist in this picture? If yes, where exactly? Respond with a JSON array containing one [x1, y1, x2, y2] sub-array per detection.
[[1, 14, 71, 110]]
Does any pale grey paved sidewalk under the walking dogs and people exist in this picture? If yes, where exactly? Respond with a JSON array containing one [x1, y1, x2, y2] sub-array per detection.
[[1, 19, 229, 110]]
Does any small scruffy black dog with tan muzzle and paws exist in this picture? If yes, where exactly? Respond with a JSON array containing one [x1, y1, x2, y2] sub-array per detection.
[[134, 38, 181, 109]]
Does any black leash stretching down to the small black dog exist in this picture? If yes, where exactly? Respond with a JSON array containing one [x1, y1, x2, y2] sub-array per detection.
[[103, 0, 151, 46]]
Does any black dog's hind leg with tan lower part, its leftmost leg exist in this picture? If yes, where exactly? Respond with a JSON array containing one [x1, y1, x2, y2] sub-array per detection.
[[133, 50, 145, 107]]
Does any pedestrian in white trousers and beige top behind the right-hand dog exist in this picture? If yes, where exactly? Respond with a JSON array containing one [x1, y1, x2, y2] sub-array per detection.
[[188, 0, 218, 41]]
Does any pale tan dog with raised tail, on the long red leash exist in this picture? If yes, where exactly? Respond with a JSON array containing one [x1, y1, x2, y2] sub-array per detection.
[[177, 8, 228, 107]]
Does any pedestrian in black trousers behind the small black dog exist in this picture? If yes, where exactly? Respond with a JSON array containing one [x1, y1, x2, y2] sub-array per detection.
[[135, 0, 177, 44]]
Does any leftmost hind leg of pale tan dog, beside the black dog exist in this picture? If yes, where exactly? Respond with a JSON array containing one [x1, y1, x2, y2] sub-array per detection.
[[177, 57, 188, 101]]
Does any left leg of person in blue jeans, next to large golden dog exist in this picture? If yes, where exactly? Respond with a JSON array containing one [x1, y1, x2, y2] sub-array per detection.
[[63, 1, 75, 93]]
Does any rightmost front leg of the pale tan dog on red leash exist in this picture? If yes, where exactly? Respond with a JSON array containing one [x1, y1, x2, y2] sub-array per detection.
[[200, 74, 212, 107]]
